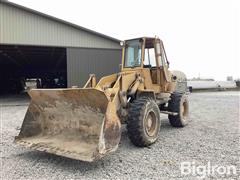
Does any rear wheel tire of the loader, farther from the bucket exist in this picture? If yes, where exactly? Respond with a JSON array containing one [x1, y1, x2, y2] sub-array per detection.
[[168, 93, 189, 127]]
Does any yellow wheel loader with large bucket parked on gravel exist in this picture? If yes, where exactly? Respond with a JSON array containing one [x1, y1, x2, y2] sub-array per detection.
[[15, 37, 189, 162]]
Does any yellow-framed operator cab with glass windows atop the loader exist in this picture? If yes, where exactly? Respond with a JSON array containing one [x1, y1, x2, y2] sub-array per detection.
[[122, 37, 170, 84]]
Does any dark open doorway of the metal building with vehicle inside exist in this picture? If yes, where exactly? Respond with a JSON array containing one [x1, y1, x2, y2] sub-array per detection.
[[0, 45, 67, 94]]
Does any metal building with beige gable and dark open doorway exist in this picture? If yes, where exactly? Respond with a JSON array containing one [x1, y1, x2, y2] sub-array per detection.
[[0, 1, 121, 93]]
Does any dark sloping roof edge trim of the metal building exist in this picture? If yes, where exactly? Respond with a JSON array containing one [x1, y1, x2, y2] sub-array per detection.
[[0, 0, 121, 42]]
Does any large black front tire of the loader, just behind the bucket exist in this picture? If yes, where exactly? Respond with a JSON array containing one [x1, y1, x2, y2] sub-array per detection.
[[127, 97, 161, 147]]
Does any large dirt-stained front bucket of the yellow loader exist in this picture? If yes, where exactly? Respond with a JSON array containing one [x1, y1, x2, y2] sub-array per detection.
[[15, 88, 121, 162]]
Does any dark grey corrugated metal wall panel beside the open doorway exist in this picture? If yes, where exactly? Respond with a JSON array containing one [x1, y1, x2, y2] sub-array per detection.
[[67, 48, 122, 87]]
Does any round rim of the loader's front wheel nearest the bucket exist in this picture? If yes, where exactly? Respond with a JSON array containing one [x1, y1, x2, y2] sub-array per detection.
[[145, 111, 157, 136]]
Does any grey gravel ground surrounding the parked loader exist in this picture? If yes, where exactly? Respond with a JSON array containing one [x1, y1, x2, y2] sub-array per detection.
[[0, 92, 240, 179]]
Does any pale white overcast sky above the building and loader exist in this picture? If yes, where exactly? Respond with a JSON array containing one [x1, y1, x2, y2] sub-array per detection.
[[11, 0, 240, 80]]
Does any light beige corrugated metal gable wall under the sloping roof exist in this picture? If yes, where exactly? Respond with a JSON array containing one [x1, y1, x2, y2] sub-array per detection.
[[0, 3, 120, 49]]
